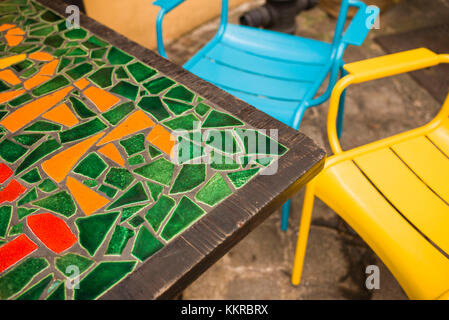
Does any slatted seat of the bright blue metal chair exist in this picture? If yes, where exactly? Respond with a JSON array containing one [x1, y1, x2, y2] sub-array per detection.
[[185, 24, 332, 125]]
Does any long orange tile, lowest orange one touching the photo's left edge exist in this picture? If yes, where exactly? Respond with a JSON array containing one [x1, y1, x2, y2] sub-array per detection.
[[0, 86, 73, 132]]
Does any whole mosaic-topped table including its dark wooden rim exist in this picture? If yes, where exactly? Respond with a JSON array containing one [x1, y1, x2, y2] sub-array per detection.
[[0, 0, 324, 300]]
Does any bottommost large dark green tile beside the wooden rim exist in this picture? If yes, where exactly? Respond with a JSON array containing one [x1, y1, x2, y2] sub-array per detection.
[[74, 261, 136, 300]]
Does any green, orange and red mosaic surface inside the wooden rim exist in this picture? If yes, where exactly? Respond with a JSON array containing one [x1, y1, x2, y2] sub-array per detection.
[[0, 0, 326, 300]]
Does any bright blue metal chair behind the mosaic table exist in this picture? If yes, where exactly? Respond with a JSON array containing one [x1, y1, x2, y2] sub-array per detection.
[[154, 0, 379, 230]]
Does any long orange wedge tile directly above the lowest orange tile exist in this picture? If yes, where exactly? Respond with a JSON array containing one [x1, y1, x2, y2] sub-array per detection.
[[42, 133, 104, 183]]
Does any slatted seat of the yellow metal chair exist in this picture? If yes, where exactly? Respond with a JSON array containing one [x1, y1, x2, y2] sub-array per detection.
[[315, 121, 449, 299]]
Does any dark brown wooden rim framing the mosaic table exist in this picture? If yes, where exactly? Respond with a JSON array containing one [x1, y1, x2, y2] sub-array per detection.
[[34, 0, 325, 299]]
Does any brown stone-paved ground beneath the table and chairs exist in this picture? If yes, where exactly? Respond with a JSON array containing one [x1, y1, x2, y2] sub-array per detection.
[[167, 0, 449, 299]]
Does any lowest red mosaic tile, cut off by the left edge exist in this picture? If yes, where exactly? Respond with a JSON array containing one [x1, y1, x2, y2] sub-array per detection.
[[0, 234, 37, 272]]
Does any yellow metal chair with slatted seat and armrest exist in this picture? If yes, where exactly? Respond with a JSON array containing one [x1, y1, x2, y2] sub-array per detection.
[[292, 48, 449, 299]]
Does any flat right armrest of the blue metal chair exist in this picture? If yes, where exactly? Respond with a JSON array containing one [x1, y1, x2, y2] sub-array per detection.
[[342, 0, 379, 46]]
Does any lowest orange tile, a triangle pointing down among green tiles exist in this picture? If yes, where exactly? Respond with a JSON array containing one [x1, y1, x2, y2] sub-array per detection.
[[66, 177, 109, 216]]
